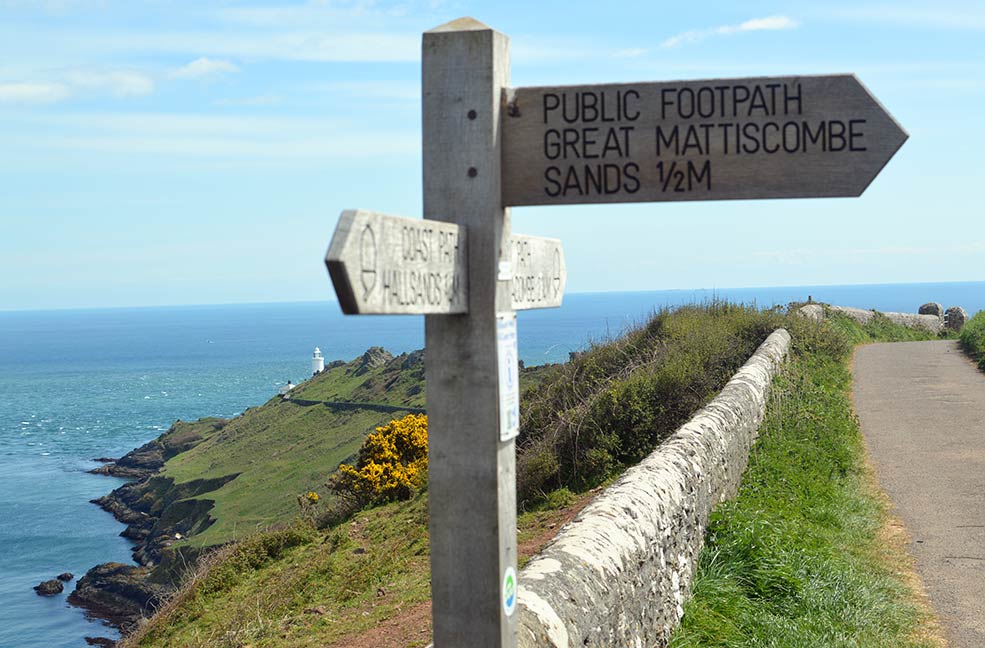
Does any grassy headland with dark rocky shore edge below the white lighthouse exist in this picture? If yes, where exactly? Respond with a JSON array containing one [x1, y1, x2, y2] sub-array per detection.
[[69, 347, 424, 633]]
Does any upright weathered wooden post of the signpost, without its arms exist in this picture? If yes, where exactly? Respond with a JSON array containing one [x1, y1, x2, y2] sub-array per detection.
[[422, 18, 519, 648]]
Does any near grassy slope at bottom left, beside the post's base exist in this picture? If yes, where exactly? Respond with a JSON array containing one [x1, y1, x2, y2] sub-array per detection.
[[121, 494, 430, 648]]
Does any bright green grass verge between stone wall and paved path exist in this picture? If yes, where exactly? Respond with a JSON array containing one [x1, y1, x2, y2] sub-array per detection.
[[671, 317, 936, 648]]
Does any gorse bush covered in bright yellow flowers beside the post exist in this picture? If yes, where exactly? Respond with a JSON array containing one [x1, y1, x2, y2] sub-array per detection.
[[329, 414, 428, 504]]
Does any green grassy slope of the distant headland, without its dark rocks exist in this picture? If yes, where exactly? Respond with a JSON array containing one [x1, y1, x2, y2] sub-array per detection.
[[149, 349, 424, 547]]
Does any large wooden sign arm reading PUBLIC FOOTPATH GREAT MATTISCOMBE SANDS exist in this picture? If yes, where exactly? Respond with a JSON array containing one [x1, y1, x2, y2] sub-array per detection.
[[502, 75, 907, 206]]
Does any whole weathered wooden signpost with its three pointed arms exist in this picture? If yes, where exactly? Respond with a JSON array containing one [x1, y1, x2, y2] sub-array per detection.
[[326, 18, 907, 648]]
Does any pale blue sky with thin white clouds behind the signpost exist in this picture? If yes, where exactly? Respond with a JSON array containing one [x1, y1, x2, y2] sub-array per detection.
[[0, 0, 985, 310]]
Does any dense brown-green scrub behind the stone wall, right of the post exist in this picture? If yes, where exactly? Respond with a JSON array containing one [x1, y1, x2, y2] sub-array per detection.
[[517, 302, 788, 501]]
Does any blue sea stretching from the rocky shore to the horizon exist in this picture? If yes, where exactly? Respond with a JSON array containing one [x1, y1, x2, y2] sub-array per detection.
[[0, 282, 985, 648]]
